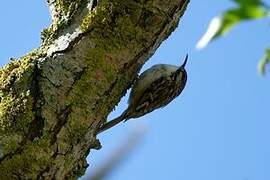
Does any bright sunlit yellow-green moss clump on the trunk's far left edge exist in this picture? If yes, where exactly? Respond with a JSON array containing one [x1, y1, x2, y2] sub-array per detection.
[[0, 51, 39, 155]]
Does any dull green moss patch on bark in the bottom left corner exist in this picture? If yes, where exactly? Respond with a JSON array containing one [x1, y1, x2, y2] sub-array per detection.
[[0, 136, 53, 179]]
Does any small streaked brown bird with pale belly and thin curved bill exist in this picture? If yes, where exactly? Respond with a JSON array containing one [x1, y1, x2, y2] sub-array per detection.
[[97, 54, 188, 134]]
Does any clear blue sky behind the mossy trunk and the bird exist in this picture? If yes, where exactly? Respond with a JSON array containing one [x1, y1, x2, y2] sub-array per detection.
[[0, 0, 270, 180]]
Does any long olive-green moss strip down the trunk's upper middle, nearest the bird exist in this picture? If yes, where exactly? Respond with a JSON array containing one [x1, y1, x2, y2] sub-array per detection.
[[66, 1, 145, 129]]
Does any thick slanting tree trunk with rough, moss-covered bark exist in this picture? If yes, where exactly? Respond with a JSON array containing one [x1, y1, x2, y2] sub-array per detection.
[[0, 0, 189, 179]]
